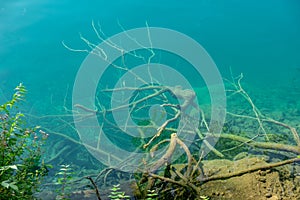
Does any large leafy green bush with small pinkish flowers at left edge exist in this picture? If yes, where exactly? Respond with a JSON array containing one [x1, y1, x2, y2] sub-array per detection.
[[0, 84, 48, 199]]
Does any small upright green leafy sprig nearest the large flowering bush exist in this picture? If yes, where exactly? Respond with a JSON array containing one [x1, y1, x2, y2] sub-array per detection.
[[56, 165, 73, 199]]
